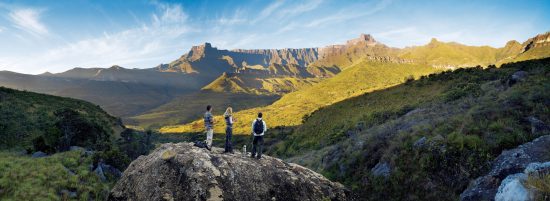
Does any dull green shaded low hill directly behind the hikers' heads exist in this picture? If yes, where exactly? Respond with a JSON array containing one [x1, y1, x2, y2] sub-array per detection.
[[125, 91, 279, 128]]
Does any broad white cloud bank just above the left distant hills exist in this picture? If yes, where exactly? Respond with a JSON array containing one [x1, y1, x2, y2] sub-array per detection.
[[0, 4, 193, 73]]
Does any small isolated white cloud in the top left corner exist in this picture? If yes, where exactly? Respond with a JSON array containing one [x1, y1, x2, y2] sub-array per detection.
[[8, 8, 48, 36]]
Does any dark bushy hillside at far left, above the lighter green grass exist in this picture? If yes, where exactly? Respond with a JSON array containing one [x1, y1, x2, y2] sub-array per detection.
[[0, 87, 122, 149]]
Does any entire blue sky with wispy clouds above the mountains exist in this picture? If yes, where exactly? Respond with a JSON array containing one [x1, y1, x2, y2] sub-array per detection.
[[0, 0, 550, 74]]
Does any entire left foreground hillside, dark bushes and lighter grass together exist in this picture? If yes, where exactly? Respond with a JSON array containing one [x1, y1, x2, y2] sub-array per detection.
[[0, 87, 153, 200]]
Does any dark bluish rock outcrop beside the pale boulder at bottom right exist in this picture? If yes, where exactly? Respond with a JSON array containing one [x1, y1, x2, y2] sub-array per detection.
[[460, 135, 550, 201]]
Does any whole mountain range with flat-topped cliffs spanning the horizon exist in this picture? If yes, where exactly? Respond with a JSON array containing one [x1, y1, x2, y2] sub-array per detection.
[[0, 33, 550, 131]]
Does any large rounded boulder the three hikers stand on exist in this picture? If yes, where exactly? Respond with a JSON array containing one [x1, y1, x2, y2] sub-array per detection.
[[109, 143, 352, 200]]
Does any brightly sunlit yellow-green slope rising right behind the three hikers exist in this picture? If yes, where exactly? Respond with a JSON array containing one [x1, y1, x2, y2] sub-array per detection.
[[160, 60, 438, 134]]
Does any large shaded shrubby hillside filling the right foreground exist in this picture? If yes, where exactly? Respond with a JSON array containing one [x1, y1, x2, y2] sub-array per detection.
[[274, 59, 550, 200]]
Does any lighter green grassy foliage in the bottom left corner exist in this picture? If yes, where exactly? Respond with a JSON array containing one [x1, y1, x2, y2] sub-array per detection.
[[0, 151, 114, 201]]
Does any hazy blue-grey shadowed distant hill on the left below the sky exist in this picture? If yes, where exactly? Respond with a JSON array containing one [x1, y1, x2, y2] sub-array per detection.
[[0, 66, 207, 117]]
